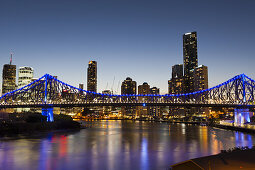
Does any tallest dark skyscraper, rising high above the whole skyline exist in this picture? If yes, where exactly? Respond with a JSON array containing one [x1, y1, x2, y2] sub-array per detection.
[[183, 32, 198, 93]]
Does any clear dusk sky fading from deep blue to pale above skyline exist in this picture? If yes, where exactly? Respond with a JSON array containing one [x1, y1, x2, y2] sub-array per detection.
[[0, 0, 255, 94]]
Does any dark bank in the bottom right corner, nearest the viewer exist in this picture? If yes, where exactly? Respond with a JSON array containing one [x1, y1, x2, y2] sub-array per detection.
[[171, 147, 255, 170]]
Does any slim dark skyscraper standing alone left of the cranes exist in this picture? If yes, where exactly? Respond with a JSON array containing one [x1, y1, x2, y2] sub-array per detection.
[[87, 61, 97, 92]]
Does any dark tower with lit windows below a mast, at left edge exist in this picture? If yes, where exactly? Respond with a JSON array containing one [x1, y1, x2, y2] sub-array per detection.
[[2, 64, 16, 94]]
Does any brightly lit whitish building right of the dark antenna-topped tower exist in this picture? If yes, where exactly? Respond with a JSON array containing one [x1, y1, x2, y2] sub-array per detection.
[[18, 67, 34, 88]]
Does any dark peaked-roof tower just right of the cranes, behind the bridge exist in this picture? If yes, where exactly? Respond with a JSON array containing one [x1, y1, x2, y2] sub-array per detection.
[[121, 77, 136, 119]]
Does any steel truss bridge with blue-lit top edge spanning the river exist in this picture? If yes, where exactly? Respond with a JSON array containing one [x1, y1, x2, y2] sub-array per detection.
[[0, 74, 255, 121]]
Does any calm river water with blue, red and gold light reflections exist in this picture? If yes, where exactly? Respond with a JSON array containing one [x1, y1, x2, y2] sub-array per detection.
[[0, 120, 255, 170]]
